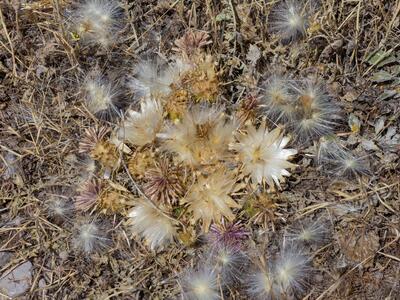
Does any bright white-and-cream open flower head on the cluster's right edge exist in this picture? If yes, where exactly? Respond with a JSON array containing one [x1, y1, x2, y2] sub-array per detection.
[[232, 123, 297, 187]]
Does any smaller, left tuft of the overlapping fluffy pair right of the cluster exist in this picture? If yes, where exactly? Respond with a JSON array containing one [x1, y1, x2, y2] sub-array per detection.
[[261, 76, 296, 122]]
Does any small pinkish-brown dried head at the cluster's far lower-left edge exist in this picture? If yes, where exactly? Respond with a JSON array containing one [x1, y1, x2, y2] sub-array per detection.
[[74, 179, 104, 211]]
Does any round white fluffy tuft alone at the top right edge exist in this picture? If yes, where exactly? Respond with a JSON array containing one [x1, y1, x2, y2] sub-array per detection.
[[268, 0, 309, 43]]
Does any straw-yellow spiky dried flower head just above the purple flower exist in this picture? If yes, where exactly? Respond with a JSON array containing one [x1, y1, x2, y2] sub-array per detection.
[[182, 169, 240, 232]]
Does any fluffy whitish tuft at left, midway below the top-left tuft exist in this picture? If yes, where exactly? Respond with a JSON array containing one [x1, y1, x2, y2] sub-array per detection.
[[83, 73, 119, 118]]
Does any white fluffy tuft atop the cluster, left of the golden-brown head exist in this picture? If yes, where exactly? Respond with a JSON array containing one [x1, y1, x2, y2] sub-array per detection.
[[130, 58, 191, 99]]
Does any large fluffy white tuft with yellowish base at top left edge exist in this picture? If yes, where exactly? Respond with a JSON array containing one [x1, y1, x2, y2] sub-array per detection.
[[71, 0, 124, 48]]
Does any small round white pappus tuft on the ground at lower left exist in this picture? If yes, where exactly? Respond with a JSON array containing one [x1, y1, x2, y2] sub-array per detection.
[[73, 220, 110, 253]]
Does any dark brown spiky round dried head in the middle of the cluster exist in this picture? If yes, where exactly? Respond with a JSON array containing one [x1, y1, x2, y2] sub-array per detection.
[[143, 159, 185, 205]]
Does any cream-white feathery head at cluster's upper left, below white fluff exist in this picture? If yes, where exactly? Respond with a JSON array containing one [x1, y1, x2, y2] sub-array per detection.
[[118, 99, 163, 146]]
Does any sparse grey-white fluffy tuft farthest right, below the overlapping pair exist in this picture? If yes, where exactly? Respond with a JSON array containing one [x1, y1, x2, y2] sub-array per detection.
[[317, 137, 370, 178]]
